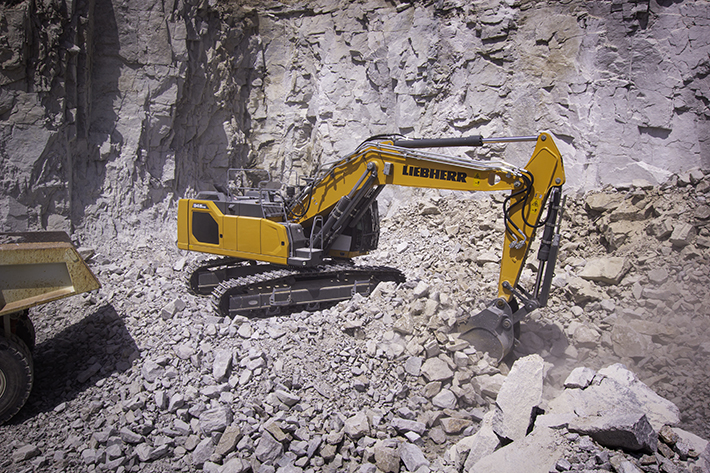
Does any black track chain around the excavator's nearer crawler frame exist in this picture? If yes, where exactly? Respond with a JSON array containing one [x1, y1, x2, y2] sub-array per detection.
[[212, 264, 405, 317]]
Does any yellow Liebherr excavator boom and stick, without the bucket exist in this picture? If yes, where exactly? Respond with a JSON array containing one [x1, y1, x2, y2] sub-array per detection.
[[289, 134, 565, 298]]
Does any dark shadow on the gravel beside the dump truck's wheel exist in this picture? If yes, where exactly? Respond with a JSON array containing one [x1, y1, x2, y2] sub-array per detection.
[[13, 305, 138, 423]]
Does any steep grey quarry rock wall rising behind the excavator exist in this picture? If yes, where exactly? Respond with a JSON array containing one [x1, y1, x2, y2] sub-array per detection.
[[0, 0, 710, 236]]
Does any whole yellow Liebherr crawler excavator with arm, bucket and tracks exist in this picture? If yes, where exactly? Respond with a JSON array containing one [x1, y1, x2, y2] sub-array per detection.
[[178, 133, 565, 360]]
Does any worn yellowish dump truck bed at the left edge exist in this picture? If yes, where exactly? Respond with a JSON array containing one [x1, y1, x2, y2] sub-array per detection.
[[0, 232, 101, 316]]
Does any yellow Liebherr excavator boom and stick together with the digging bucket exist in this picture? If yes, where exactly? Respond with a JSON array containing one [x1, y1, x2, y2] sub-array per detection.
[[290, 133, 565, 359]]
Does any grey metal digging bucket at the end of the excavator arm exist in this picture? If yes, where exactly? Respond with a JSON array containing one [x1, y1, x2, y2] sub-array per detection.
[[456, 298, 515, 363]]
